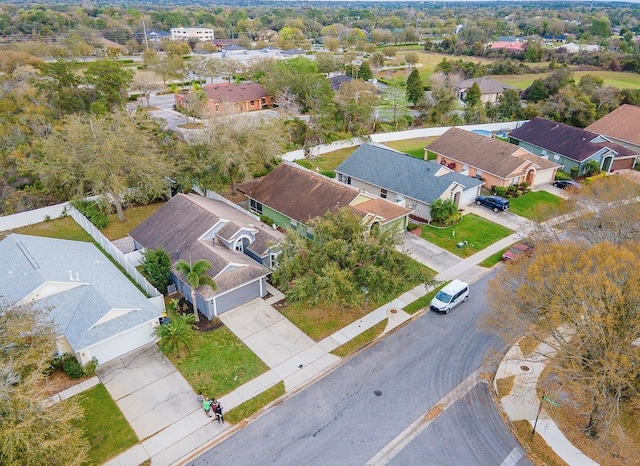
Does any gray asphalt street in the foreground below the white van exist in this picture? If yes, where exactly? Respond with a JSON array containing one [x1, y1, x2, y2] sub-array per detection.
[[190, 275, 531, 466]]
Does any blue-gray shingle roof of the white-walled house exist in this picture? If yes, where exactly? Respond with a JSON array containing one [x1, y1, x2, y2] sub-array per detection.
[[336, 144, 482, 204]]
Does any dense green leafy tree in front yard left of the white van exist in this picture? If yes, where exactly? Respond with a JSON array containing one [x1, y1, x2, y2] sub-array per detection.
[[273, 208, 430, 305]]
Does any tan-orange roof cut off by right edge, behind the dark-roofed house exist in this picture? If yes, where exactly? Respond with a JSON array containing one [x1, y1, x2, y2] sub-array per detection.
[[585, 104, 640, 154]]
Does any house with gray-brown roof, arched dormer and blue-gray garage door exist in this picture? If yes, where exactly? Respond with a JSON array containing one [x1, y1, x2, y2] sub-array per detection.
[[130, 194, 284, 319]]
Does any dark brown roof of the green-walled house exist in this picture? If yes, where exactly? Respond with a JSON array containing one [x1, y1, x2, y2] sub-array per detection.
[[238, 162, 409, 224]]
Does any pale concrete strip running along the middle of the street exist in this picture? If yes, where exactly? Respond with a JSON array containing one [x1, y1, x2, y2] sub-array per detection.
[[365, 367, 484, 466]]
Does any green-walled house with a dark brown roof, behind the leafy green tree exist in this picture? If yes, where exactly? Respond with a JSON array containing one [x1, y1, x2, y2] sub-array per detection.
[[238, 162, 409, 238]]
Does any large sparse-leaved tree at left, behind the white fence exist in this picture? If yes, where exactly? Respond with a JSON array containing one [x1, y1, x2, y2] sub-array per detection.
[[26, 112, 173, 222]]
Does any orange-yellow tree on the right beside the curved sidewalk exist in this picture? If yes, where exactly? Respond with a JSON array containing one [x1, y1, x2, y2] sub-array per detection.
[[488, 242, 640, 438]]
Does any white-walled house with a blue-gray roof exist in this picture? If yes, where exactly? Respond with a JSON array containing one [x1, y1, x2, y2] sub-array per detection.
[[336, 144, 482, 220]]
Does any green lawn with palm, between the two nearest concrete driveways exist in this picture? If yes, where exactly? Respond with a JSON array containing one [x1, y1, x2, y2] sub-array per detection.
[[167, 324, 269, 398]]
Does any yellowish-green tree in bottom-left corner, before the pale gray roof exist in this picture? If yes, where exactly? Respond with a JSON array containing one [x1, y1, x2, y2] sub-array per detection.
[[0, 303, 89, 466]]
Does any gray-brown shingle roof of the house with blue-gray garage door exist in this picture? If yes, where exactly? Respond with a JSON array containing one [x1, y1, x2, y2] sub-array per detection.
[[130, 194, 284, 298]]
